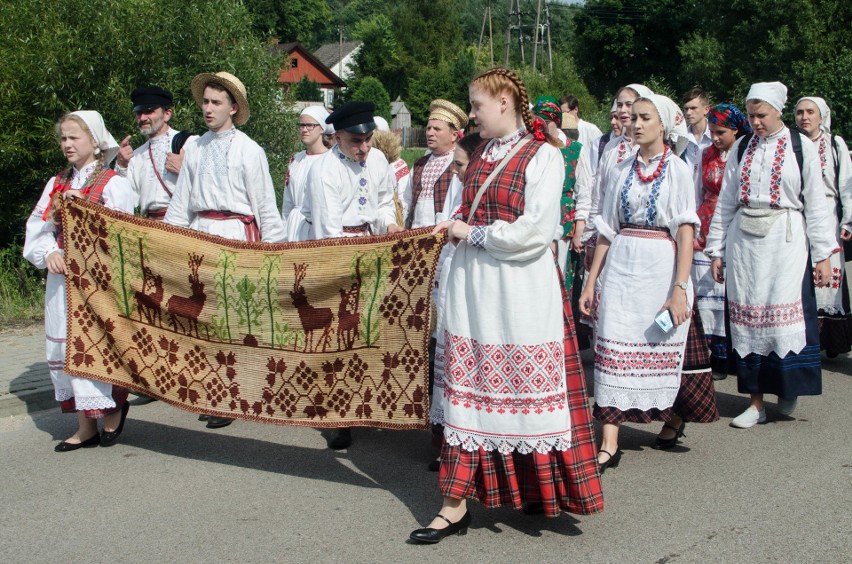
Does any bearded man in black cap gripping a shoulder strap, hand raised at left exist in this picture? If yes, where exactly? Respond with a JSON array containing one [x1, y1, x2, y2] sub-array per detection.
[[116, 86, 197, 221]]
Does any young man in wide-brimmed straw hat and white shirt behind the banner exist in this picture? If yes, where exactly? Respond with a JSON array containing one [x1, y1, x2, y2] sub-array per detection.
[[165, 72, 286, 428]]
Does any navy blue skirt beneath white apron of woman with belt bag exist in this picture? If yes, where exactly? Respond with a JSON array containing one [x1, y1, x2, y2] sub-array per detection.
[[725, 258, 822, 399]]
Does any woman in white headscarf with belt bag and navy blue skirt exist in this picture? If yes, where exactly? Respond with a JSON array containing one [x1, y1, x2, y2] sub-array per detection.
[[704, 82, 840, 429]]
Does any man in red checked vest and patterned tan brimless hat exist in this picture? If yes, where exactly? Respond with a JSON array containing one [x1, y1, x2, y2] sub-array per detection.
[[400, 99, 468, 229]]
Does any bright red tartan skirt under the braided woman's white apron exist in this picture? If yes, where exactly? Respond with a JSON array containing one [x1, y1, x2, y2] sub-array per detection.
[[439, 268, 603, 517]]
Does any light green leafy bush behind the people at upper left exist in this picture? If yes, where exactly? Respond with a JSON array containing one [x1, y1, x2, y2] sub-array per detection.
[[0, 0, 297, 247]]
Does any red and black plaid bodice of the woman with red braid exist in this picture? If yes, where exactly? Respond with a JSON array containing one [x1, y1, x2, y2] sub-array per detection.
[[459, 139, 545, 225]]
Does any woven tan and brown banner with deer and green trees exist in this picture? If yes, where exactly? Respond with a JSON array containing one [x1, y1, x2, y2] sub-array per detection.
[[62, 200, 443, 429]]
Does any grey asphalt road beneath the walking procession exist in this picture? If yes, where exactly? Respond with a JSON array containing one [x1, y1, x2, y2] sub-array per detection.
[[0, 357, 852, 564]]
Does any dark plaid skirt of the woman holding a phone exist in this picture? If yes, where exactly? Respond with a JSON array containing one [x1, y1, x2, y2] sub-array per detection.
[[594, 305, 719, 425]]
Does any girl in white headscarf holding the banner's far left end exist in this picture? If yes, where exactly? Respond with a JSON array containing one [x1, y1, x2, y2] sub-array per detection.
[[24, 111, 136, 452]]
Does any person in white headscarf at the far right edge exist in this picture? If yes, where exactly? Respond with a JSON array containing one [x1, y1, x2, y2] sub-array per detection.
[[795, 96, 852, 358]]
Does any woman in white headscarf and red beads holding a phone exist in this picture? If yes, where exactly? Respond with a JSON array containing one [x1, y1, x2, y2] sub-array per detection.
[[580, 94, 719, 470]]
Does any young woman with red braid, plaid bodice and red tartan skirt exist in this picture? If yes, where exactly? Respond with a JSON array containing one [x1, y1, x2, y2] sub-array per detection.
[[411, 67, 603, 543]]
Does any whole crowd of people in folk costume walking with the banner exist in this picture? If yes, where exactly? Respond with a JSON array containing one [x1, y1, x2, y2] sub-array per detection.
[[24, 67, 852, 543]]
